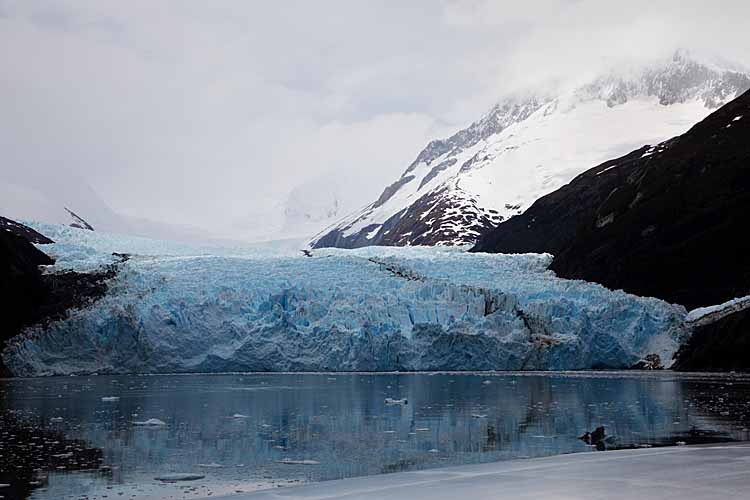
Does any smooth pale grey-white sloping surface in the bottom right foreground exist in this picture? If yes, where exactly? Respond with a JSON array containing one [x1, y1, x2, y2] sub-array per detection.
[[226, 445, 750, 500]]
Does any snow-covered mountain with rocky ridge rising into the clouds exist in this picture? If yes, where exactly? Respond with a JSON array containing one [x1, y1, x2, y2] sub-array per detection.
[[311, 51, 750, 248]]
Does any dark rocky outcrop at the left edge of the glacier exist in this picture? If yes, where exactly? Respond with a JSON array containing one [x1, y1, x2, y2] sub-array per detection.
[[0, 219, 119, 376]]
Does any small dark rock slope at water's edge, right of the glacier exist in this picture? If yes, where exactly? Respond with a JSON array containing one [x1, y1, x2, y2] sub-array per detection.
[[672, 309, 750, 372]]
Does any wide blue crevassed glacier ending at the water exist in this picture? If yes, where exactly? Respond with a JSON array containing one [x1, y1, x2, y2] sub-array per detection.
[[3, 224, 686, 376]]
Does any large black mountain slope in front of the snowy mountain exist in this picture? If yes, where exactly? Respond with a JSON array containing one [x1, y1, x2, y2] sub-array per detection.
[[473, 88, 750, 309]]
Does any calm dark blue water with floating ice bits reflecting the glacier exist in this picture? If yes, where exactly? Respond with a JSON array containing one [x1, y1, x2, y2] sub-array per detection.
[[0, 372, 750, 499]]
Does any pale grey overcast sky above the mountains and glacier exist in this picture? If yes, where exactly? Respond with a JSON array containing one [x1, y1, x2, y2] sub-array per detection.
[[0, 0, 750, 234]]
